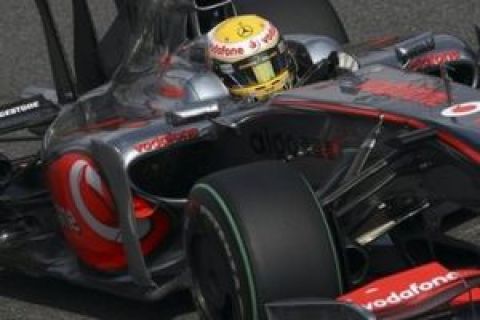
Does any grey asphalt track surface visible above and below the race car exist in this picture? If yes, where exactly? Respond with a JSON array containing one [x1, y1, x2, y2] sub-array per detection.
[[0, 0, 480, 320]]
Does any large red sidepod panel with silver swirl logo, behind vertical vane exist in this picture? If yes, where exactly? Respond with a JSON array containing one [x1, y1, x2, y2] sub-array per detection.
[[46, 152, 170, 271]]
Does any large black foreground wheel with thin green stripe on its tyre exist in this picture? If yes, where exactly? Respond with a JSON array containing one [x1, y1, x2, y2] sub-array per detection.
[[186, 162, 342, 320]]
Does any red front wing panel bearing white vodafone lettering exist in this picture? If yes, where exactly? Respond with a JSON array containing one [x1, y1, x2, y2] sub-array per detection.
[[337, 262, 480, 319]]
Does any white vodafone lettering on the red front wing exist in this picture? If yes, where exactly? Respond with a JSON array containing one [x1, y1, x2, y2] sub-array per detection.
[[362, 272, 460, 311]]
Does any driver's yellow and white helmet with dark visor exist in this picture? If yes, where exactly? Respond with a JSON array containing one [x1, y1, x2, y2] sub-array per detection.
[[208, 15, 292, 99]]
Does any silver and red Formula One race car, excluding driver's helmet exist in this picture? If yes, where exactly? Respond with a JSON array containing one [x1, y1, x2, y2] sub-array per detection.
[[4, 0, 480, 320]]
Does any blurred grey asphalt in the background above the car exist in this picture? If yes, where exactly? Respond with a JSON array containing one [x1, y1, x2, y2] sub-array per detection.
[[0, 0, 480, 102]]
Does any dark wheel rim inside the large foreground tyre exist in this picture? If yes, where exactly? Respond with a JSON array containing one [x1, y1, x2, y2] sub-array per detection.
[[188, 214, 244, 320]]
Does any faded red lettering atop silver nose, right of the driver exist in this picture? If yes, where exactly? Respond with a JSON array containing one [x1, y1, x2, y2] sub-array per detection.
[[358, 80, 448, 108]]
